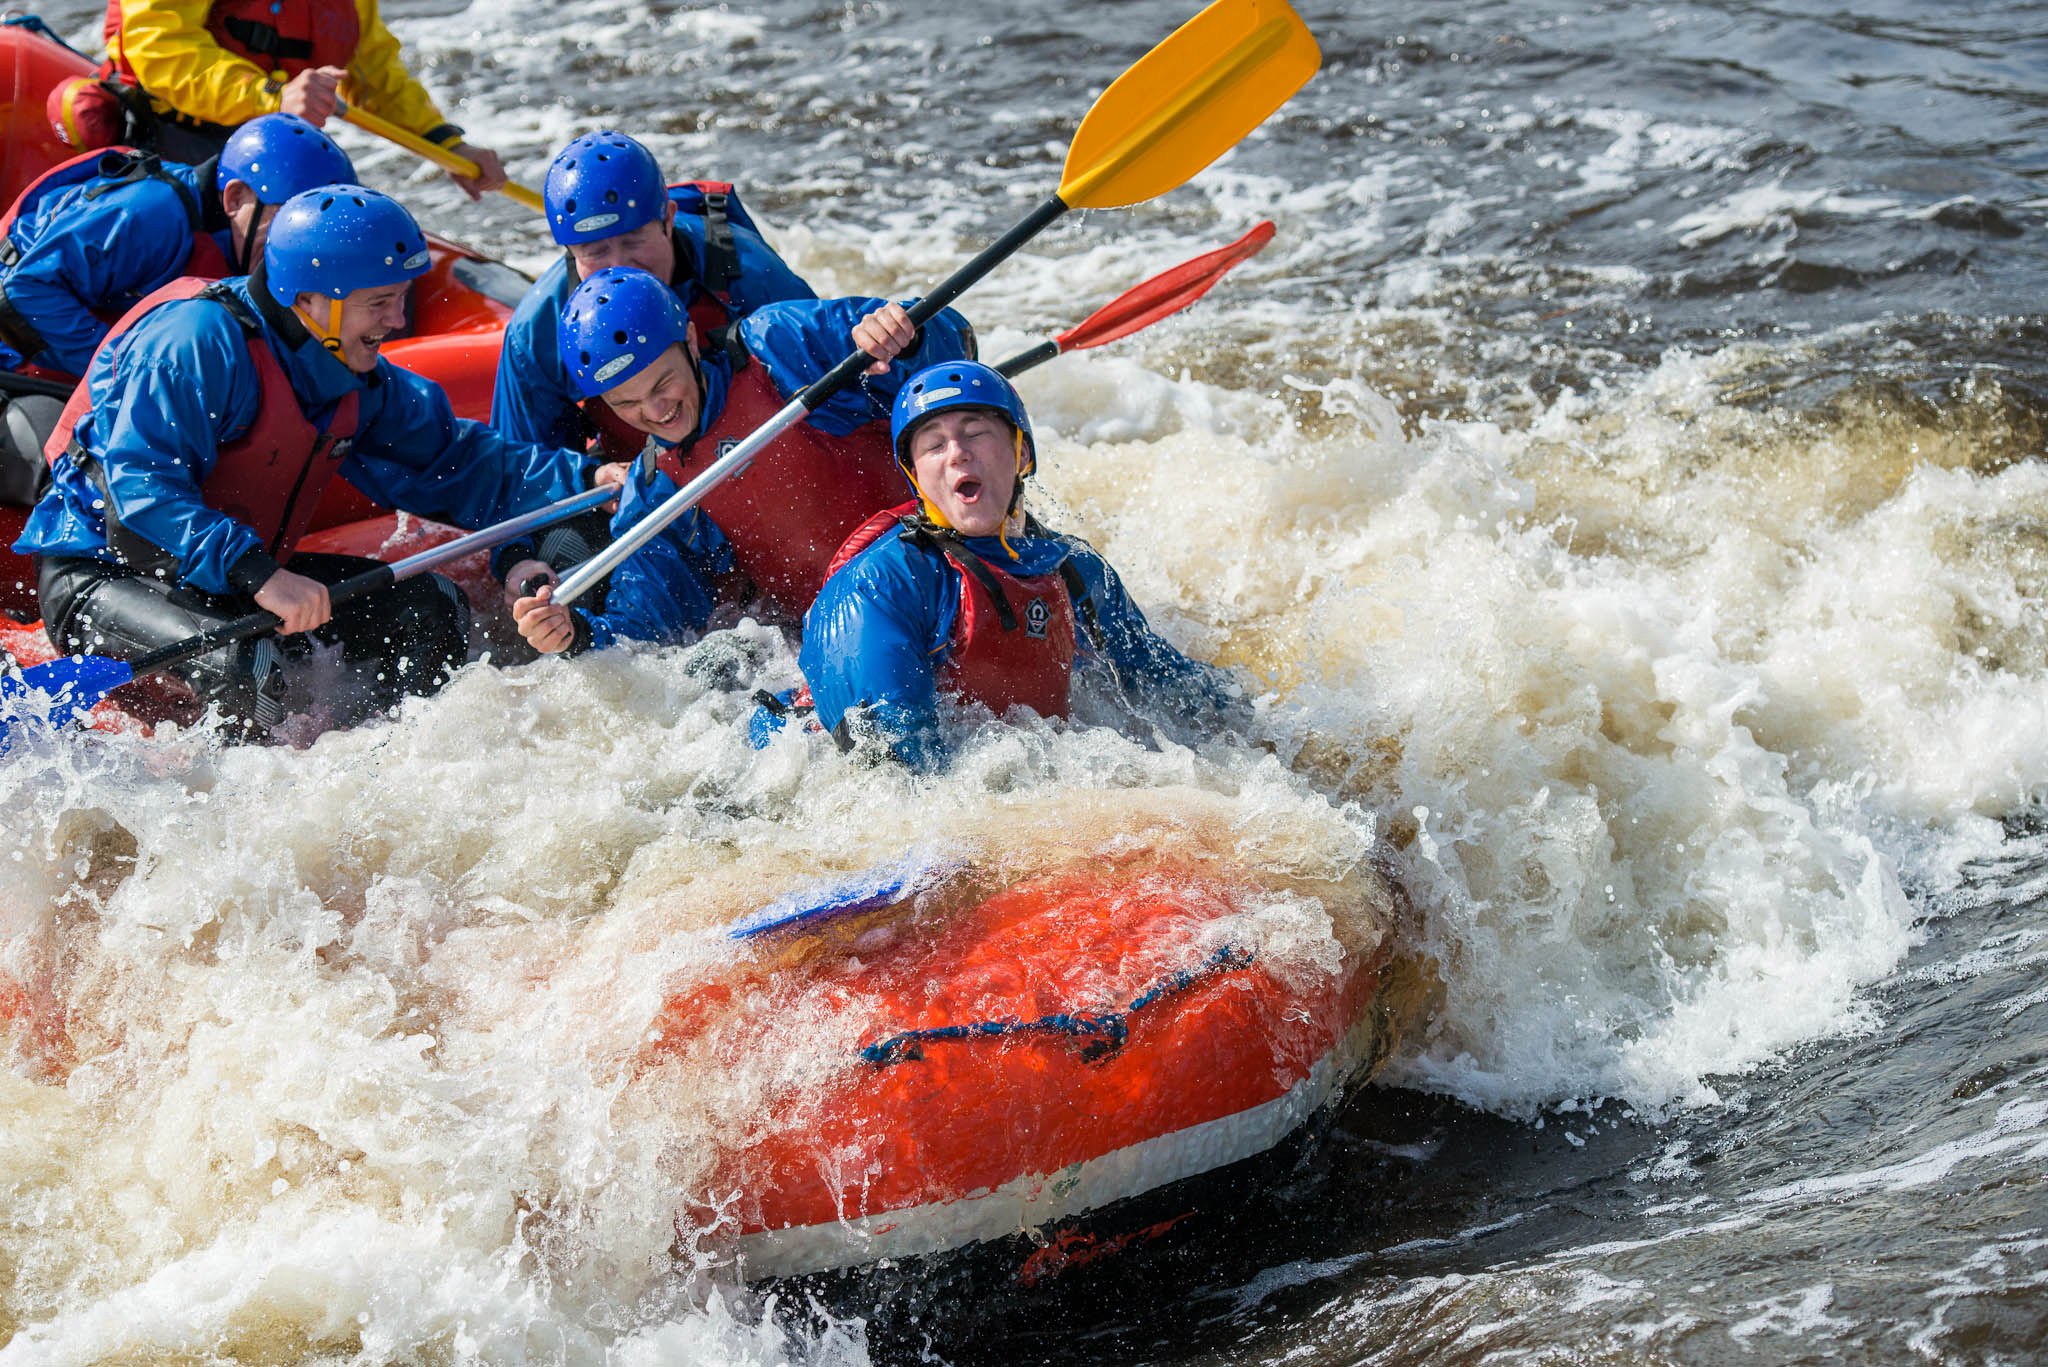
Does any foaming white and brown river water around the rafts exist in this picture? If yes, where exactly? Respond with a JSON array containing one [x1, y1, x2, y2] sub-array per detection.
[[0, 0, 2048, 1365]]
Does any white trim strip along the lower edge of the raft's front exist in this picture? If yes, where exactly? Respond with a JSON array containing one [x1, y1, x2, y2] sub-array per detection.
[[735, 1012, 1372, 1281]]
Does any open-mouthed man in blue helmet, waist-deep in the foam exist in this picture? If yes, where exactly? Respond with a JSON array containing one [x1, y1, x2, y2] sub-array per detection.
[[756, 363, 1243, 769]]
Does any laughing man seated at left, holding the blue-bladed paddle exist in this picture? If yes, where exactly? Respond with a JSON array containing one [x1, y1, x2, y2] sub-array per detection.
[[14, 184, 582, 737]]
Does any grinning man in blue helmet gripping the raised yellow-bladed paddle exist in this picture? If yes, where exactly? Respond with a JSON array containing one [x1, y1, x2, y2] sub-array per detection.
[[506, 266, 950, 654]]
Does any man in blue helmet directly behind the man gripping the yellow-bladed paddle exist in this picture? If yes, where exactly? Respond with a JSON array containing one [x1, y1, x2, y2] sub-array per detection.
[[492, 129, 817, 455]]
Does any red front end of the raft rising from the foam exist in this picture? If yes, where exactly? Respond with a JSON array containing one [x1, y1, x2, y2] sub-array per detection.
[[651, 867, 1401, 1279]]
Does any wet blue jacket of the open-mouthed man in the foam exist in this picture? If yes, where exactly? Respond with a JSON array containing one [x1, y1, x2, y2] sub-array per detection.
[[786, 523, 1243, 771]]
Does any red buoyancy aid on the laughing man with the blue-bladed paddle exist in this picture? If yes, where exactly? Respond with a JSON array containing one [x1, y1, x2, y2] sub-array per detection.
[[43, 277, 358, 564]]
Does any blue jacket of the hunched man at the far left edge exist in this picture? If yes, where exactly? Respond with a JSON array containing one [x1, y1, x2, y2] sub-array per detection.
[[0, 156, 233, 375]]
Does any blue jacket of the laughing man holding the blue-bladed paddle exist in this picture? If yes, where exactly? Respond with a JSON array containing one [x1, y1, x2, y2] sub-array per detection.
[[14, 277, 584, 594]]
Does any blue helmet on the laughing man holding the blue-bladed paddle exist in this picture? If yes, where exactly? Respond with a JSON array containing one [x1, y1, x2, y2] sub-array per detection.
[[262, 184, 430, 307]]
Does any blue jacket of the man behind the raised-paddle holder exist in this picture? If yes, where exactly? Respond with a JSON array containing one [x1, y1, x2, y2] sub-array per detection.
[[492, 184, 815, 447]]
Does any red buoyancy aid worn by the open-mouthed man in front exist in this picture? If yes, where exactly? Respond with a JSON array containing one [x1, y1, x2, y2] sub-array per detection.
[[825, 498, 1075, 717]]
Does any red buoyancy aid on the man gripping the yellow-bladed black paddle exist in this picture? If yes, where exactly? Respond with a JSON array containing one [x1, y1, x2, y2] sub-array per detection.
[[590, 344, 903, 617]]
